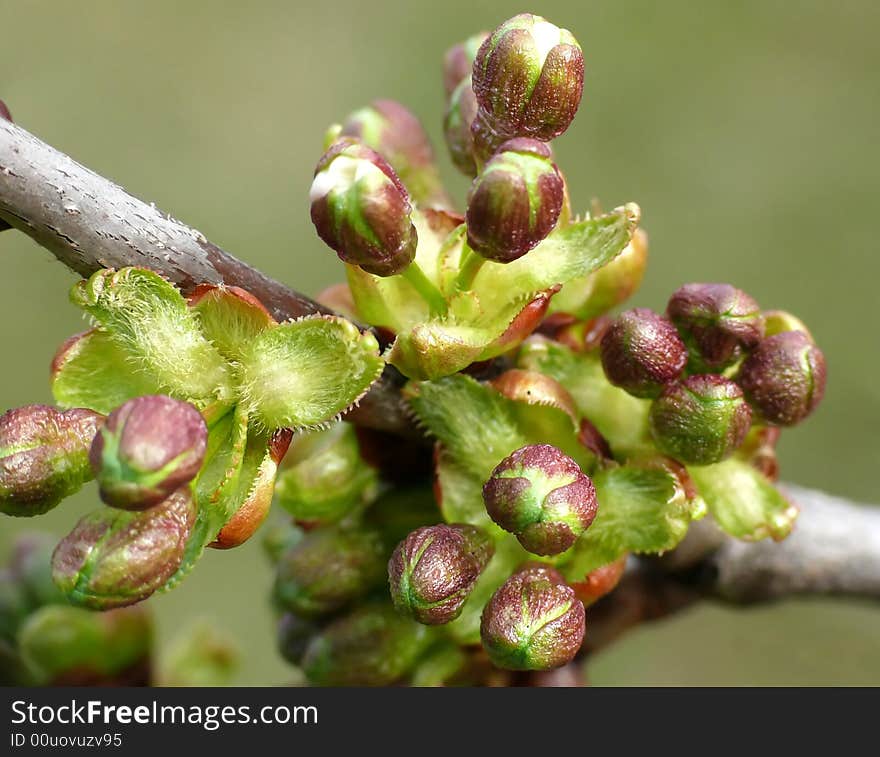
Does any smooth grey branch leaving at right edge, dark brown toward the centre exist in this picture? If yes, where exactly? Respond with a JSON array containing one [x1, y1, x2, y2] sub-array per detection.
[[584, 484, 880, 654]]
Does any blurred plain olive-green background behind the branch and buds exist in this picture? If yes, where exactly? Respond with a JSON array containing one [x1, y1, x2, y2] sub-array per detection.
[[0, 0, 880, 684]]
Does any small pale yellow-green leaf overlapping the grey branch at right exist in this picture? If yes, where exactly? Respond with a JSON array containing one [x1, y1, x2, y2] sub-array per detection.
[[688, 460, 798, 541]]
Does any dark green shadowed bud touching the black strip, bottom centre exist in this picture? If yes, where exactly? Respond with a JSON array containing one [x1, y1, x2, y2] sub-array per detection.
[[302, 605, 430, 686]]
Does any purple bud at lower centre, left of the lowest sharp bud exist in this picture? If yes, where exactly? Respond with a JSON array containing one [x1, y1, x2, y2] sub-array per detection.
[[388, 524, 495, 625]]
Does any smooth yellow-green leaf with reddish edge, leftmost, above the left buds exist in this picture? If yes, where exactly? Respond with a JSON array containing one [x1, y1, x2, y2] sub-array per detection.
[[52, 329, 160, 415]]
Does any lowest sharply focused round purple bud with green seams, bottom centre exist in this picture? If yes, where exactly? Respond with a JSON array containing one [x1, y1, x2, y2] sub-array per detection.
[[480, 565, 585, 670]]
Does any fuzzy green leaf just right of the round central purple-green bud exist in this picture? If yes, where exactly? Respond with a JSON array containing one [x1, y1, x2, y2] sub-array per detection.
[[562, 467, 705, 580]]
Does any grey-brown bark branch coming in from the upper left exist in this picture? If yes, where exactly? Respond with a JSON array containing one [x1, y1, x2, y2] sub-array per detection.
[[0, 117, 416, 436]]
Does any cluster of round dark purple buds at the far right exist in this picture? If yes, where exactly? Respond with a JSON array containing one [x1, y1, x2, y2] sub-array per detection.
[[600, 284, 826, 465]]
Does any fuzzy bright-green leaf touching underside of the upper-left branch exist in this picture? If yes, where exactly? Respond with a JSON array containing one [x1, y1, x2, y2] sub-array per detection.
[[70, 268, 232, 408]]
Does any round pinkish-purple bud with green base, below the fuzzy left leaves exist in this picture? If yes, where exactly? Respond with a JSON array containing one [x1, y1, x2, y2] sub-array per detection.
[[89, 394, 208, 510]]
